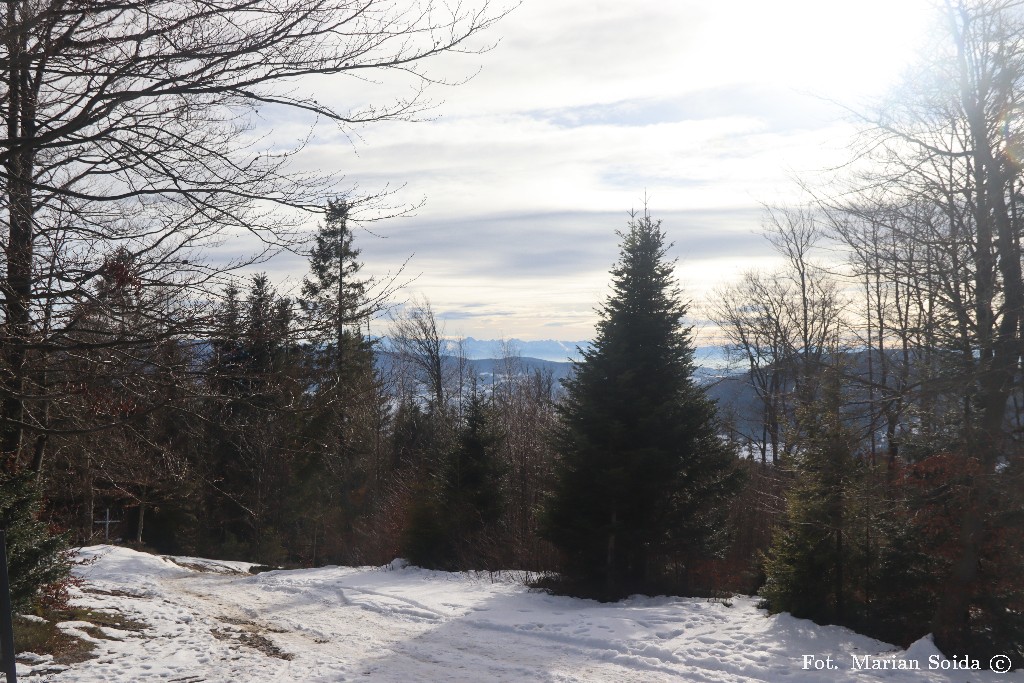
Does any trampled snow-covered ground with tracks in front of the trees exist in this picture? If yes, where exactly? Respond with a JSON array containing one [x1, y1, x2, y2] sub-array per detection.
[[18, 546, 1024, 683]]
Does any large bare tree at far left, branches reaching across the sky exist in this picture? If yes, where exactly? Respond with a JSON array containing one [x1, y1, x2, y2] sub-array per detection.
[[0, 0, 505, 470]]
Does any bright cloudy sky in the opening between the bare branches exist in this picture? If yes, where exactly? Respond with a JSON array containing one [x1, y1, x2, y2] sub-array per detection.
[[269, 0, 933, 340]]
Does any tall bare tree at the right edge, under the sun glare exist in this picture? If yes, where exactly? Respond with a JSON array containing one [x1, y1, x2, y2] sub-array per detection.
[[843, 0, 1024, 652]]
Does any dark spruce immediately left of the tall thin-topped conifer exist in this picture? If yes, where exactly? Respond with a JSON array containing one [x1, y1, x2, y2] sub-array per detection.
[[205, 274, 307, 562]]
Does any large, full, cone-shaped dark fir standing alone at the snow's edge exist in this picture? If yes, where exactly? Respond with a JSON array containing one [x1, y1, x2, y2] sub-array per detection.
[[545, 213, 738, 599]]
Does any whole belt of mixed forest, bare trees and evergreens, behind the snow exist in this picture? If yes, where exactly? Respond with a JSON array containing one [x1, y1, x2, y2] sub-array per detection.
[[0, 0, 1024, 667]]
